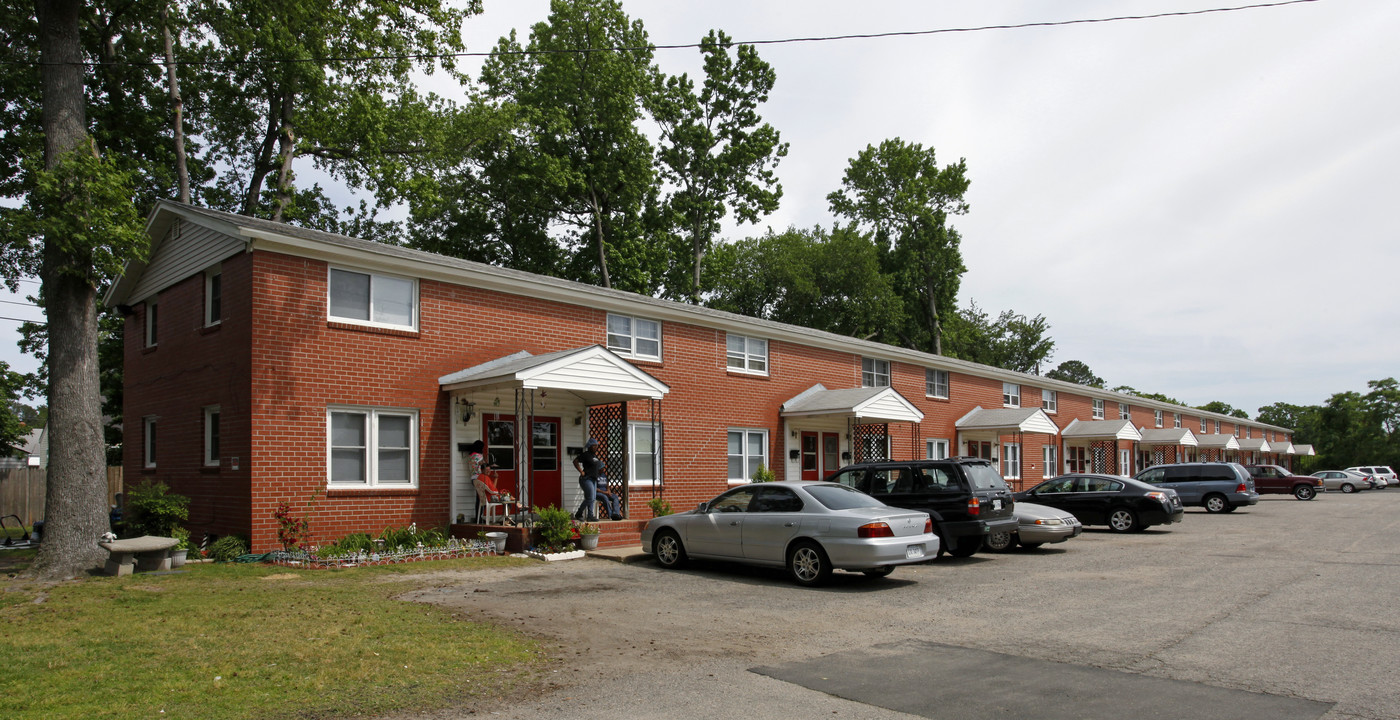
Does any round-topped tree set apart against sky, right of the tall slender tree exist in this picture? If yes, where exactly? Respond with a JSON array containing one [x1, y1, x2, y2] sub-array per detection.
[[826, 139, 969, 354]]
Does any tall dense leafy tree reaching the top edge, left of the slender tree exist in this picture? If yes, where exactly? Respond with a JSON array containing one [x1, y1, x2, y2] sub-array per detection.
[[482, 0, 665, 293]]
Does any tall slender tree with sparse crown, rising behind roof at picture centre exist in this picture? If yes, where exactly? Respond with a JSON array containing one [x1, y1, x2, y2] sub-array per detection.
[[645, 29, 788, 303]]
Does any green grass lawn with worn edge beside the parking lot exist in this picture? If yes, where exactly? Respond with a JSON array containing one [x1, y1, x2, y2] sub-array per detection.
[[0, 551, 546, 720]]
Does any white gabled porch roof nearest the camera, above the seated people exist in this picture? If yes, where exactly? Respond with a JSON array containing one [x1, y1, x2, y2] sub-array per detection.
[[438, 345, 671, 405]]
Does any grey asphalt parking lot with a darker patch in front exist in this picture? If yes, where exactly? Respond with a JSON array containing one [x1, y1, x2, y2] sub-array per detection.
[[400, 489, 1400, 720]]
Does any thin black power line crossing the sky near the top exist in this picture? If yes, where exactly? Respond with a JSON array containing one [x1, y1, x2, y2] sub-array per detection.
[[0, 0, 1320, 67]]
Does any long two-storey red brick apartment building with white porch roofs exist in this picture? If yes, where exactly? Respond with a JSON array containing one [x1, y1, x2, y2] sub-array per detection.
[[106, 202, 1310, 552]]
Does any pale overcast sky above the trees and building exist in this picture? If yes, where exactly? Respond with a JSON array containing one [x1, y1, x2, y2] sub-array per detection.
[[0, 0, 1400, 416]]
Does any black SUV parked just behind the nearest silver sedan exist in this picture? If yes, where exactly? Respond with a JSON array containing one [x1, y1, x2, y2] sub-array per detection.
[[827, 458, 1016, 558]]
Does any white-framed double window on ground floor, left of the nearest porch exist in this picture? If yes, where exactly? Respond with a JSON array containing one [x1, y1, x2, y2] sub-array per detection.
[[326, 408, 419, 487]]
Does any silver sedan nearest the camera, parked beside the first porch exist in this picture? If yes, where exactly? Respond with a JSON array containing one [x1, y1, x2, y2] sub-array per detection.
[[641, 482, 938, 586]]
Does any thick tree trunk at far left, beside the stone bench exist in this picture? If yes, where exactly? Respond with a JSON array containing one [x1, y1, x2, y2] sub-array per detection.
[[29, 0, 108, 580]]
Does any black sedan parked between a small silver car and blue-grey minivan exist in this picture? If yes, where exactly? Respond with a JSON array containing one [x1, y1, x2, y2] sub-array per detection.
[[1015, 475, 1186, 532]]
